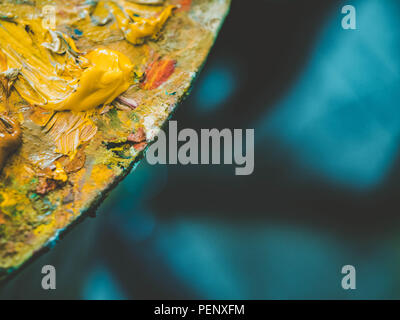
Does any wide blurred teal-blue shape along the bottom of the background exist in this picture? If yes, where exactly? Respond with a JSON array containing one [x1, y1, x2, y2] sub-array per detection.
[[155, 220, 396, 299]]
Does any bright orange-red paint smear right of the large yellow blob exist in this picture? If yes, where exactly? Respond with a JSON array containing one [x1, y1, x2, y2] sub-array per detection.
[[141, 59, 176, 90]]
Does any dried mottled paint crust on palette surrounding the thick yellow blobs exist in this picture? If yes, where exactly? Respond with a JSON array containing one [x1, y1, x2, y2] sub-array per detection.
[[0, 0, 230, 280]]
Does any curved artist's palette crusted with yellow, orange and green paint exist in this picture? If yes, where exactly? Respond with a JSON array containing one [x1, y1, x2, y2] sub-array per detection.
[[0, 0, 230, 279]]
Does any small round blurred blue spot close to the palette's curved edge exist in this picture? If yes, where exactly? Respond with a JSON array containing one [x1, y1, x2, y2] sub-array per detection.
[[194, 61, 237, 113]]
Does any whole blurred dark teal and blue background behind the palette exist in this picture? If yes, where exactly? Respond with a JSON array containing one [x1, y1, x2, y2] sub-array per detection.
[[0, 0, 400, 299]]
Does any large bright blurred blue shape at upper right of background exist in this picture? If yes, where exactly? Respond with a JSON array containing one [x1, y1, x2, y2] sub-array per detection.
[[259, 0, 400, 189]]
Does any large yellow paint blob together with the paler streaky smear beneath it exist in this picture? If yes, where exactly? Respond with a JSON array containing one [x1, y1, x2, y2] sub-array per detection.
[[0, 15, 134, 155]]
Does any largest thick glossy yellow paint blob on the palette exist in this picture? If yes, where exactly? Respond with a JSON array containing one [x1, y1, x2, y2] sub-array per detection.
[[0, 20, 133, 112]]
